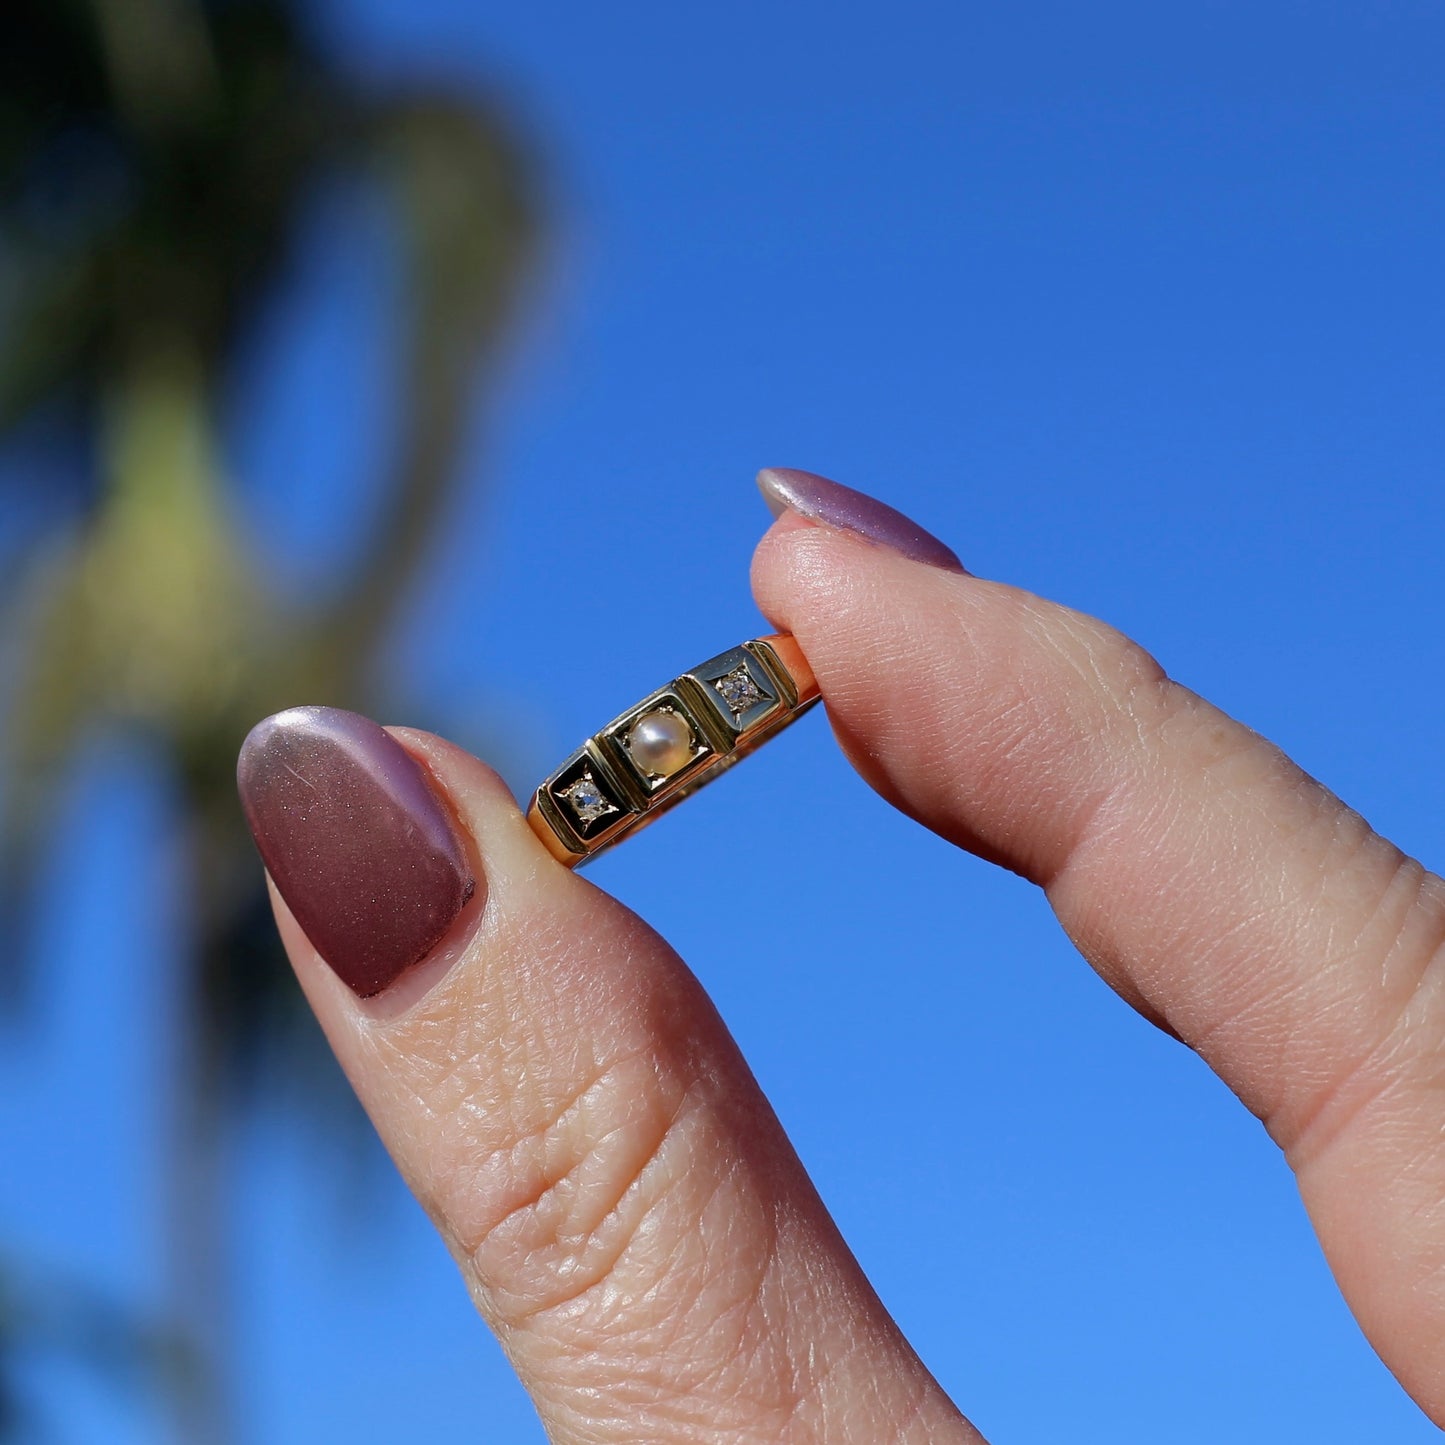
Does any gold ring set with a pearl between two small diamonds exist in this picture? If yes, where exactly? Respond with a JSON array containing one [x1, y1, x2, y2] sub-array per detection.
[[527, 633, 818, 868]]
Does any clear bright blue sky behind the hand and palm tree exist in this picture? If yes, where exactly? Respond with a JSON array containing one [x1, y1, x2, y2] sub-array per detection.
[[0, 0, 1445, 1445]]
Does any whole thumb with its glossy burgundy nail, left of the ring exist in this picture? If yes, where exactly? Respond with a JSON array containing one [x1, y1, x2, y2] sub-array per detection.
[[240, 708, 978, 1445]]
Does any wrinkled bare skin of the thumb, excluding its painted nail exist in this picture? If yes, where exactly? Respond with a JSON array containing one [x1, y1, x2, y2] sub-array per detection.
[[279, 731, 978, 1442]]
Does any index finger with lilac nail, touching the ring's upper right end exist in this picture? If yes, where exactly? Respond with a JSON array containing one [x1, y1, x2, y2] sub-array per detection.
[[753, 473, 1445, 1423]]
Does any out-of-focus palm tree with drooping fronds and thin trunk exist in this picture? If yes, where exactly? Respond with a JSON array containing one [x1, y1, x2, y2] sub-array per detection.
[[0, 0, 533, 1441]]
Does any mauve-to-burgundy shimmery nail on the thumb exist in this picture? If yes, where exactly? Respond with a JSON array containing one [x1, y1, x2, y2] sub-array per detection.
[[236, 708, 477, 998]]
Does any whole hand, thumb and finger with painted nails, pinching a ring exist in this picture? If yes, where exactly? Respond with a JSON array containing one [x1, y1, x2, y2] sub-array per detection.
[[241, 473, 1445, 1445]]
